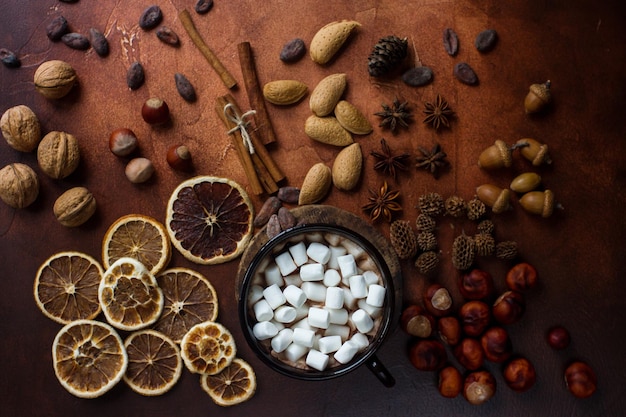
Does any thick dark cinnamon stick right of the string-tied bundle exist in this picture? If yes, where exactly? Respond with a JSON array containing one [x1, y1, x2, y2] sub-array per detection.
[[237, 42, 276, 145]]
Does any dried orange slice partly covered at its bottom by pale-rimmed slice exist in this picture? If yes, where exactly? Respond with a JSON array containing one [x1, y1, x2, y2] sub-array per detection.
[[102, 214, 172, 274]]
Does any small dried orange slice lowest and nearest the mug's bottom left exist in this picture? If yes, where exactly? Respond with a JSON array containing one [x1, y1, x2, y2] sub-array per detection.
[[200, 358, 256, 407]]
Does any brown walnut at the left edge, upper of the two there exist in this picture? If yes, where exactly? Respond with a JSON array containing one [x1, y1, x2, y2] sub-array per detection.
[[0, 104, 41, 152]]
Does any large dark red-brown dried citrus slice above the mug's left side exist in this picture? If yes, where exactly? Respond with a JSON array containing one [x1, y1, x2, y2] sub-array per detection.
[[165, 176, 253, 265]]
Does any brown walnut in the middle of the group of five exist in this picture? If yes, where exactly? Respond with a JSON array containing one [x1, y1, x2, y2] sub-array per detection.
[[37, 131, 80, 179]]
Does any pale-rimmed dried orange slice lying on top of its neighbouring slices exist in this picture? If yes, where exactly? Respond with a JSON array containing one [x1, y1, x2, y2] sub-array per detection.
[[98, 258, 164, 331]]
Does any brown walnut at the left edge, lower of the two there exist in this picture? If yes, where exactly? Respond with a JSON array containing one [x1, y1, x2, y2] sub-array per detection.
[[0, 163, 39, 208]]
